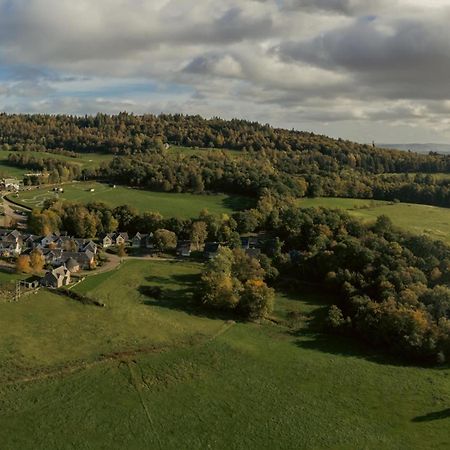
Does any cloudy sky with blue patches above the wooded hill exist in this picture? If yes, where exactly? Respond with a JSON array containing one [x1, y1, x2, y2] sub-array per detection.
[[0, 0, 450, 143]]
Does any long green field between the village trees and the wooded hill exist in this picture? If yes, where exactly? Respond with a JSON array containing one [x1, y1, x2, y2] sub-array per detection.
[[12, 182, 253, 218]]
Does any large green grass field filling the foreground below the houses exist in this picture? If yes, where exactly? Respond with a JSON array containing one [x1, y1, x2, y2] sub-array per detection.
[[0, 260, 450, 450]]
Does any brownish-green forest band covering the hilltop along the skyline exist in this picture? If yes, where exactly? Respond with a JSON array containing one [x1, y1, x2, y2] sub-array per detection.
[[0, 113, 450, 173]]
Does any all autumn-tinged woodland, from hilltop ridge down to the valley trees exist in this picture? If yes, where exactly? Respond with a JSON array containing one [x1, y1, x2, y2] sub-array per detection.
[[5, 114, 450, 363]]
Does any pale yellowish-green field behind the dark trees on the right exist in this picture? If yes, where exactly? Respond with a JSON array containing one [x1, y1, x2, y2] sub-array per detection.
[[299, 197, 450, 243]]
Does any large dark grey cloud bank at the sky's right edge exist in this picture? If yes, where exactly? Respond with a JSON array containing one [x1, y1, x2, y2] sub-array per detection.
[[277, 14, 450, 98]]
